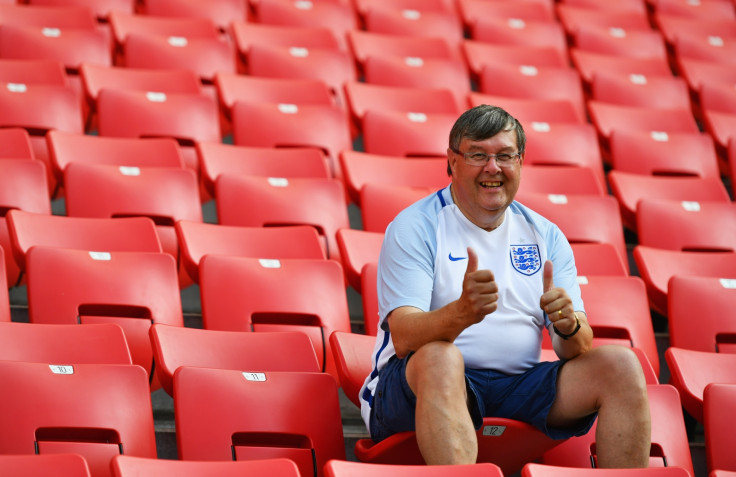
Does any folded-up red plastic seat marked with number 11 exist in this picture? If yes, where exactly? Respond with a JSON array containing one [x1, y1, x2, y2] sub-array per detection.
[[174, 367, 345, 477]]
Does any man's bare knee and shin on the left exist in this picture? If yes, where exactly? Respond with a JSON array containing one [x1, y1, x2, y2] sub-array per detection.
[[406, 341, 478, 465]]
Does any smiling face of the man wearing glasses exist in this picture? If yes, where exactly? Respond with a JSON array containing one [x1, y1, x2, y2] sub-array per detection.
[[447, 129, 523, 230]]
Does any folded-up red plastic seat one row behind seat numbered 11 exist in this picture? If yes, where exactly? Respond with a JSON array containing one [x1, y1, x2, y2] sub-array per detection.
[[199, 255, 350, 375]]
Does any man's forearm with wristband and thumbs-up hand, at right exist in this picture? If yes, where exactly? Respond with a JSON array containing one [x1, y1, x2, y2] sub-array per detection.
[[539, 260, 593, 359]]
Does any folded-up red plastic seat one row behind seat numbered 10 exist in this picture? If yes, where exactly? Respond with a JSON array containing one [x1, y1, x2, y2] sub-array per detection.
[[27, 247, 184, 389]]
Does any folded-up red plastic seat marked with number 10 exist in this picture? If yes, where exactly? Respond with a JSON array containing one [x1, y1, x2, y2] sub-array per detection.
[[0, 361, 156, 477]]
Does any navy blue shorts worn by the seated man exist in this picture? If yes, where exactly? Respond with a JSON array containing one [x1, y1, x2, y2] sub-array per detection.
[[370, 356, 597, 442]]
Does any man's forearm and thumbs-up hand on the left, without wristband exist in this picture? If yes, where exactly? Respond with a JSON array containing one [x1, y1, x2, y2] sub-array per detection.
[[388, 247, 498, 358]]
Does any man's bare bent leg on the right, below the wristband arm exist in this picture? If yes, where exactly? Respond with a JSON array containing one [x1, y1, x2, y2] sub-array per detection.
[[547, 346, 651, 468]]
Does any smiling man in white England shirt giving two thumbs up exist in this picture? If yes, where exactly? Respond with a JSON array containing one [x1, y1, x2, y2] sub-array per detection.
[[361, 105, 651, 468]]
